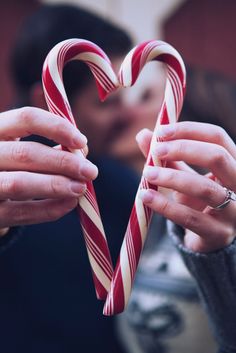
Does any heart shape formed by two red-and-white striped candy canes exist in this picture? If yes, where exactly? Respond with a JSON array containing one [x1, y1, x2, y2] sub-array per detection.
[[42, 39, 186, 315]]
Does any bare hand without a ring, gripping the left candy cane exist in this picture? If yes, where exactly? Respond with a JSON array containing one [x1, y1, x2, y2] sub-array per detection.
[[0, 108, 97, 228]]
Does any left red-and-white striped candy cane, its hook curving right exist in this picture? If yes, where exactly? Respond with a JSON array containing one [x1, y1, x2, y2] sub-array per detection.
[[42, 39, 119, 299]]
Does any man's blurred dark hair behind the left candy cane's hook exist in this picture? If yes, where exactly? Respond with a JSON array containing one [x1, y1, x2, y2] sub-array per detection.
[[11, 5, 132, 104]]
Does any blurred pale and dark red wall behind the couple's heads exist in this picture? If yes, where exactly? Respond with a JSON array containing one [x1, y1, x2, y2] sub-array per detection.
[[0, 0, 236, 113]]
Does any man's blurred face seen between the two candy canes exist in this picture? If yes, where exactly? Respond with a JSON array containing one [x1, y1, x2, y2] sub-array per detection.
[[72, 59, 132, 156]]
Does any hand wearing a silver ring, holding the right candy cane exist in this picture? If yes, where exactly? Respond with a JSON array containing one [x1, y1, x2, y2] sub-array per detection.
[[137, 122, 236, 252]]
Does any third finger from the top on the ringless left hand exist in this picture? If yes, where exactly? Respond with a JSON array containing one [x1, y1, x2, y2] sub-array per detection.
[[0, 172, 86, 200]]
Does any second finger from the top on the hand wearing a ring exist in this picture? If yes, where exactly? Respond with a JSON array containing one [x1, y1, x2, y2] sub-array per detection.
[[154, 140, 236, 190]]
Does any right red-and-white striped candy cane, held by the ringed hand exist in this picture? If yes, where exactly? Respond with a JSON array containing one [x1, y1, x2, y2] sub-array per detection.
[[104, 40, 186, 315]]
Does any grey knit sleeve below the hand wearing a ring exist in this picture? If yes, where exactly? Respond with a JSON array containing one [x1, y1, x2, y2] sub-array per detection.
[[168, 222, 236, 353]]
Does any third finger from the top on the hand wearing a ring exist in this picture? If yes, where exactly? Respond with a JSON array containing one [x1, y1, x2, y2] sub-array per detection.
[[143, 166, 226, 207]]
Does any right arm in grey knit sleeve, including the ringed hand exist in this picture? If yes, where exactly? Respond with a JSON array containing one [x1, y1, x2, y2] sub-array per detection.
[[138, 122, 236, 353]]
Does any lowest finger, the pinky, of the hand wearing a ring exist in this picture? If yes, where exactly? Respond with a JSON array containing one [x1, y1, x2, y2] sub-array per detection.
[[139, 190, 235, 251]]
